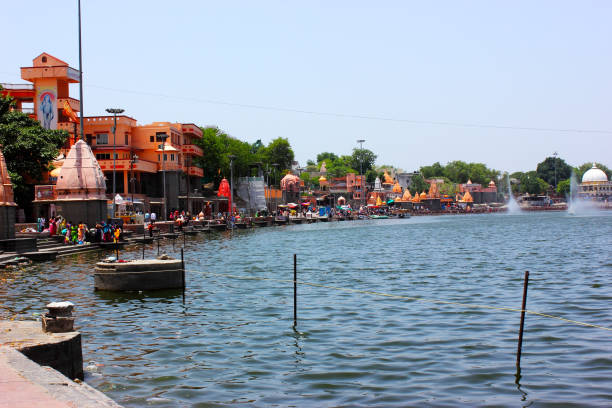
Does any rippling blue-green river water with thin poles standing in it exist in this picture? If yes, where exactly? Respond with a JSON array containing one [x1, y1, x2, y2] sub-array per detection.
[[0, 213, 612, 407]]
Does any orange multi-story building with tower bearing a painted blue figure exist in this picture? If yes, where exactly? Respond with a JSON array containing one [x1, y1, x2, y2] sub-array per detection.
[[2, 53, 204, 218]]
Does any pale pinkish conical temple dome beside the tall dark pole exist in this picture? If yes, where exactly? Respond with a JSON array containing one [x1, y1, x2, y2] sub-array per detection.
[[55, 140, 106, 200]]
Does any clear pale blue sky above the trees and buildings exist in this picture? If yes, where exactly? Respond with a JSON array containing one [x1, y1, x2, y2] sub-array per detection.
[[0, 0, 612, 172]]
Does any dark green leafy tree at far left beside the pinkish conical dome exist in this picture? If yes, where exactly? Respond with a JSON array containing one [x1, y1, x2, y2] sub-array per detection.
[[0, 91, 69, 212]]
